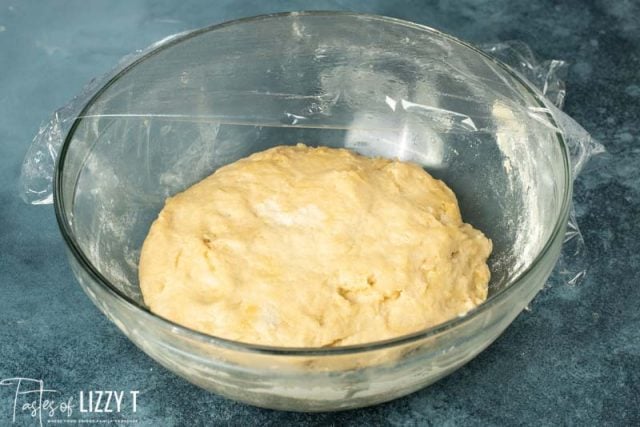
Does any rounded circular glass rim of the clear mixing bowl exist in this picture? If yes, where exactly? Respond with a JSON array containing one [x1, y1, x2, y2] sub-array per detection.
[[53, 11, 572, 356]]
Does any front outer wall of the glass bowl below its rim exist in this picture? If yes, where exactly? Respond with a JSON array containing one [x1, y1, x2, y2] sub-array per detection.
[[70, 240, 562, 412]]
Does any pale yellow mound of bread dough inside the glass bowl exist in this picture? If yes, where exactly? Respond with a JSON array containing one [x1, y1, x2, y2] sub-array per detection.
[[139, 144, 491, 347]]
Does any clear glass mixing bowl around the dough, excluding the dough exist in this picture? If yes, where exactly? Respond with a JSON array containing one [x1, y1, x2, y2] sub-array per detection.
[[54, 12, 571, 411]]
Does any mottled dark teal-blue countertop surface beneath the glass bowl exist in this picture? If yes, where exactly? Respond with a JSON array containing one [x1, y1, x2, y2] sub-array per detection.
[[0, 0, 640, 426]]
